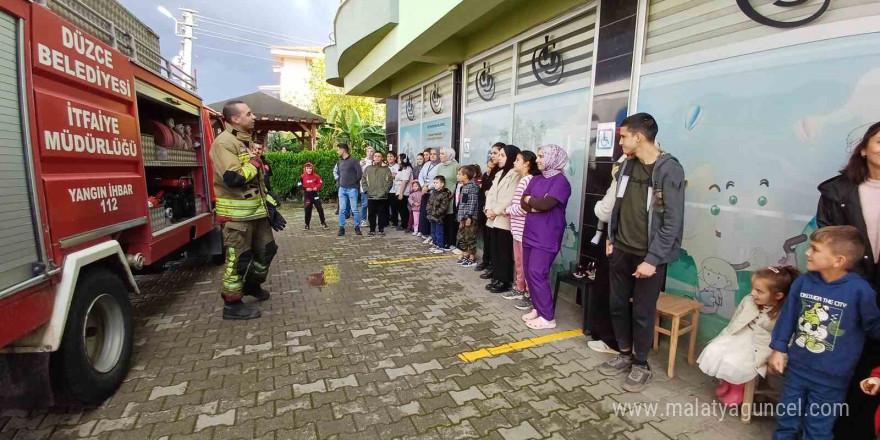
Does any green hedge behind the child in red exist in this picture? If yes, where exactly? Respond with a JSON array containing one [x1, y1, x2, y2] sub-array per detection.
[[265, 150, 338, 198]]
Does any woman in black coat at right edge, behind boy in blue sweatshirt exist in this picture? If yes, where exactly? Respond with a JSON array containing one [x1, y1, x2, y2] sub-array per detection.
[[816, 122, 880, 440]]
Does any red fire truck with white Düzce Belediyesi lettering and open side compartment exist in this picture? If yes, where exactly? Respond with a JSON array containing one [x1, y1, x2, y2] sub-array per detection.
[[0, 0, 220, 403]]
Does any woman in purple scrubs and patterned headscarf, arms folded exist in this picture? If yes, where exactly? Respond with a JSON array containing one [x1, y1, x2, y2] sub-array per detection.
[[522, 145, 571, 330]]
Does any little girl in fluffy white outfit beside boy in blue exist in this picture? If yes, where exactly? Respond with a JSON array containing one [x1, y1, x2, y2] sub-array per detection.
[[697, 266, 800, 405]]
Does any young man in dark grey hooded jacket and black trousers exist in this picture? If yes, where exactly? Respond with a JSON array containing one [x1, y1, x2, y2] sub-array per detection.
[[599, 113, 684, 392]]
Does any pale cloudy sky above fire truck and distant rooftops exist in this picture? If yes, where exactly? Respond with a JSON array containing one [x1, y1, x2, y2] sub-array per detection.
[[117, 0, 339, 104]]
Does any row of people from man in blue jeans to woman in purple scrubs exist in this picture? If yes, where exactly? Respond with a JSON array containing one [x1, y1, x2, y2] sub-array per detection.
[[337, 138, 571, 329]]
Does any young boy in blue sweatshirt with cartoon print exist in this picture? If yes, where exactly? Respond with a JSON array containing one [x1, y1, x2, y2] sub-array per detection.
[[768, 226, 880, 440]]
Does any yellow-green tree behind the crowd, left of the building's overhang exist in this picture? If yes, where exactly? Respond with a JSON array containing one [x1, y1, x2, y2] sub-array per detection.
[[309, 58, 385, 127]]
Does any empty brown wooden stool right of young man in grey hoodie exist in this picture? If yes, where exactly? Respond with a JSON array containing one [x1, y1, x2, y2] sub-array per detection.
[[654, 292, 700, 377]]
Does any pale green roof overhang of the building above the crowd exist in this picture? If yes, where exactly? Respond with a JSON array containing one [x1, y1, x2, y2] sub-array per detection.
[[324, 0, 591, 97]]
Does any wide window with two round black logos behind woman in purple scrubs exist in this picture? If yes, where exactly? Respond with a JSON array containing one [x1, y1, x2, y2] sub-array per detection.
[[461, 8, 596, 270]]
